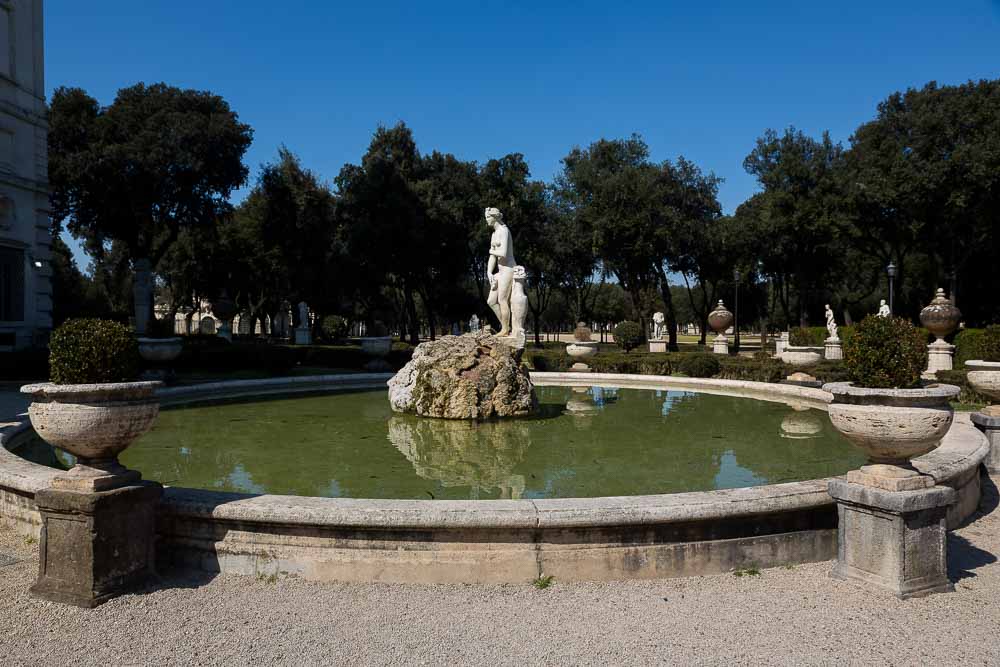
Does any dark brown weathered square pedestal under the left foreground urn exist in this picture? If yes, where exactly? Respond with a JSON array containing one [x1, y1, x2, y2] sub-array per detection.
[[31, 482, 163, 608]]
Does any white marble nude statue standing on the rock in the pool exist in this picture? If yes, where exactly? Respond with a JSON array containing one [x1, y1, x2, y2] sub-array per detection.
[[486, 208, 528, 344]]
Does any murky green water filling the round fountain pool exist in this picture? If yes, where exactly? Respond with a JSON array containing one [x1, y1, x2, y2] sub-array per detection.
[[23, 387, 864, 500]]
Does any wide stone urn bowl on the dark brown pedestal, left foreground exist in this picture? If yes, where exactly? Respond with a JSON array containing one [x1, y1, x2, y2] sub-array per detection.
[[21, 382, 163, 491]]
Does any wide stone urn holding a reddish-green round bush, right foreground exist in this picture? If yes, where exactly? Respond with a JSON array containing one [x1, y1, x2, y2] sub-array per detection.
[[823, 382, 960, 491]]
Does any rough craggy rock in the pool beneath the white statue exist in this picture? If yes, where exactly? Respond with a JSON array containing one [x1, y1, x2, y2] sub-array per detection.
[[389, 330, 538, 420]]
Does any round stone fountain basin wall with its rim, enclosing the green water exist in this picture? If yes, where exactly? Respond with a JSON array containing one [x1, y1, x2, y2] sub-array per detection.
[[0, 372, 989, 583]]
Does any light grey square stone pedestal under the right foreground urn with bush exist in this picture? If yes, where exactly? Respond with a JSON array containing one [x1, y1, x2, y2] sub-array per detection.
[[827, 479, 957, 599]]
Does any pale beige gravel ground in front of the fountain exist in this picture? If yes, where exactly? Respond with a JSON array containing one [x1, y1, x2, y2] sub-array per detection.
[[0, 480, 1000, 665]]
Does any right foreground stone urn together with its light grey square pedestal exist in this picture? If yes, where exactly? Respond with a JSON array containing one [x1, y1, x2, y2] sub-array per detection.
[[823, 382, 959, 598]]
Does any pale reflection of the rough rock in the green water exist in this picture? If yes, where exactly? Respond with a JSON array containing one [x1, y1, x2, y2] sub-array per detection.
[[388, 416, 531, 500]]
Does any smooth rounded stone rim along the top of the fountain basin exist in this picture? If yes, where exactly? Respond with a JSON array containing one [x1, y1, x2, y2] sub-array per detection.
[[0, 372, 989, 529]]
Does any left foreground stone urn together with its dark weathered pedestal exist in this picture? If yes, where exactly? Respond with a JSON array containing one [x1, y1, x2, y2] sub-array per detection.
[[21, 382, 163, 607]]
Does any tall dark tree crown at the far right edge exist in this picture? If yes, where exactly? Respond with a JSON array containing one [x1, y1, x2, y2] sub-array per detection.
[[845, 80, 1000, 319]]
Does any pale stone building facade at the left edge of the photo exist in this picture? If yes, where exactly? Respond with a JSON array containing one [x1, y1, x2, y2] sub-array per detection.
[[0, 0, 52, 350]]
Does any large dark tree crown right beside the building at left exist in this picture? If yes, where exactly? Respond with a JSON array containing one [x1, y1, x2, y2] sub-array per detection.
[[49, 83, 252, 328]]
